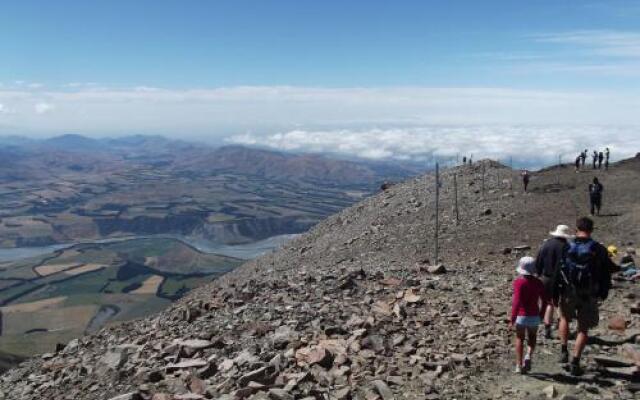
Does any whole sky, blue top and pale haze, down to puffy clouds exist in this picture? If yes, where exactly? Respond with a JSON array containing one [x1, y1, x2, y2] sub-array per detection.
[[0, 0, 640, 164]]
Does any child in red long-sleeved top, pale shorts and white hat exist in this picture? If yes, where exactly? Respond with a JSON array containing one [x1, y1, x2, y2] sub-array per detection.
[[509, 257, 545, 374]]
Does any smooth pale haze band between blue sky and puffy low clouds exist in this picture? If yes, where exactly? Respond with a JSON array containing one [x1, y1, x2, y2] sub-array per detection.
[[0, 86, 640, 138]]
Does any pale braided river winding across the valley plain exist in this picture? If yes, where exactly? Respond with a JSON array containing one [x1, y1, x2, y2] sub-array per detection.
[[0, 234, 298, 263]]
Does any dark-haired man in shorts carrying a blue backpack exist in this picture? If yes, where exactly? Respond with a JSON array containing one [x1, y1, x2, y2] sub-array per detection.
[[558, 217, 613, 376]]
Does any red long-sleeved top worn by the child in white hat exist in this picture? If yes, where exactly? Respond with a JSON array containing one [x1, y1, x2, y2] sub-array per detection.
[[511, 275, 547, 323]]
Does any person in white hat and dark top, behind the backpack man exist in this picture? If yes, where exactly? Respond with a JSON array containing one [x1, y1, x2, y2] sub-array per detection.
[[536, 225, 573, 339]]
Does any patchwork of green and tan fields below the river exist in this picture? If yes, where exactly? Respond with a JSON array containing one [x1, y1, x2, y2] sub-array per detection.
[[0, 239, 242, 356]]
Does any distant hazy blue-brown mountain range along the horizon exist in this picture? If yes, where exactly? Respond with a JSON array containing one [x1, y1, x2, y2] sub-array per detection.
[[0, 134, 421, 185]]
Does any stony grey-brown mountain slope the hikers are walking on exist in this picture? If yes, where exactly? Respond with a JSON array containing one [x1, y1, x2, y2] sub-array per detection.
[[0, 155, 640, 400]]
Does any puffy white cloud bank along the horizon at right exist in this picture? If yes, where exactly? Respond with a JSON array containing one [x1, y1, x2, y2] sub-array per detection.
[[229, 125, 640, 165]]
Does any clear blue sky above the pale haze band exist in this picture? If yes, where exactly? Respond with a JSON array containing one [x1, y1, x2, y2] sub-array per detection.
[[0, 0, 640, 89]]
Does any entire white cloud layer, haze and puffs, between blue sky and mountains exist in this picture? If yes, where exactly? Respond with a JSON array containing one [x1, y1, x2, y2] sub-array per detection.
[[0, 83, 640, 165]]
